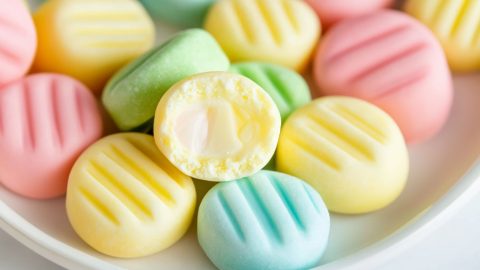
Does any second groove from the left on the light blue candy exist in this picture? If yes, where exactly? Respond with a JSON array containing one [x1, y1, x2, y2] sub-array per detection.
[[236, 178, 283, 243]]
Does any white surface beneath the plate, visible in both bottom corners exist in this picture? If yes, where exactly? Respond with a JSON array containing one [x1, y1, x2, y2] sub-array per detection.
[[0, 190, 480, 270]]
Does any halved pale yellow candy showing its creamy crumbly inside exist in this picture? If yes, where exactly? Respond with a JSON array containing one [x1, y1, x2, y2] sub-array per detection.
[[154, 72, 281, 181]]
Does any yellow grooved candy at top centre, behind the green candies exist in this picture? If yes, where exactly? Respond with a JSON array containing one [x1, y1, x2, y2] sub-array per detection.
[[205, 0, 320, 71]]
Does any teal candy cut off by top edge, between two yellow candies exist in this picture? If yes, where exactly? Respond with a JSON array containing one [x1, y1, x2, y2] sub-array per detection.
[[140, 0, 216, 27]]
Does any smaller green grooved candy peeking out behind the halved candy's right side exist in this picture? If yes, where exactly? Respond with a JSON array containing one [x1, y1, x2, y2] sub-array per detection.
[[230, 62, 312, 122]]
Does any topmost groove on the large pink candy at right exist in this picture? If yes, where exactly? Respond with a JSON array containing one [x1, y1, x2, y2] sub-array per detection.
[[327, 24, 410, 63]]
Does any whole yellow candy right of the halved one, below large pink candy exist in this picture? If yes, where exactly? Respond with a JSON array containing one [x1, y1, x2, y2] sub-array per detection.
[[277, 97, 409, 214]]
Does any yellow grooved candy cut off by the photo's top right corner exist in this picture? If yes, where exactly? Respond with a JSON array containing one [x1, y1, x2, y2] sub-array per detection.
[[405, 0, 480, 71]]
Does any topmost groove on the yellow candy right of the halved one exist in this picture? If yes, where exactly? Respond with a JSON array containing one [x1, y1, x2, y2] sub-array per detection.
[[327, 104, 387, 144]]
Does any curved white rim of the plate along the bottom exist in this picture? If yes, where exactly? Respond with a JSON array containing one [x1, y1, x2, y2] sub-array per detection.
[[0, 159, 480, 270]]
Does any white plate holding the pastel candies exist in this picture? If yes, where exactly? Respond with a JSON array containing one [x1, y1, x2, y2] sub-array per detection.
[[0, 1, 480, 269]]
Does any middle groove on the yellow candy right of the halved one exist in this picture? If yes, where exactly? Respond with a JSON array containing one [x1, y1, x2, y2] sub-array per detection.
[[305, 113, 374, 161]]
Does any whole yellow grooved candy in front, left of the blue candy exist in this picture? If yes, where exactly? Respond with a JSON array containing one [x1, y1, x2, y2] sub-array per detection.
[[67, 133, 196, 258]]
